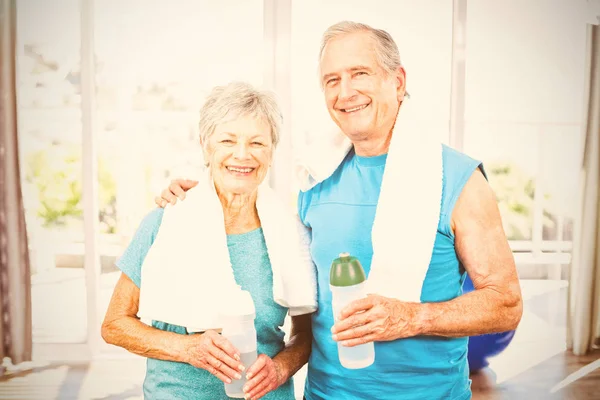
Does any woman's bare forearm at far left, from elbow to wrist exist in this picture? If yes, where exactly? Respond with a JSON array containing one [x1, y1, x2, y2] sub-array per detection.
[[102, 317, 186, 362]]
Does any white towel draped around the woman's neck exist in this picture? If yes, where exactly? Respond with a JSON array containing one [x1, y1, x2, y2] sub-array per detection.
[[138, 173, 317, 332]]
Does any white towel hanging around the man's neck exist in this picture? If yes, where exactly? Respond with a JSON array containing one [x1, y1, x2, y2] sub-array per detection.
[[295, 102, 443, 302]]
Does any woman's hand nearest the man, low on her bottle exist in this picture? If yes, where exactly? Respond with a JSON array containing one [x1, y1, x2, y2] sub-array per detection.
[[244, 354, 285, 400]]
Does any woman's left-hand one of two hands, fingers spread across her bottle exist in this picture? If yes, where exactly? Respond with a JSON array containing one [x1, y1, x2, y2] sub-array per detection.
[[184, 330, 244, 383]]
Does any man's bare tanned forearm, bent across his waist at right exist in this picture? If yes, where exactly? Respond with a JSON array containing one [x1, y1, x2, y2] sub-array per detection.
[[415, 288, 522, 337]]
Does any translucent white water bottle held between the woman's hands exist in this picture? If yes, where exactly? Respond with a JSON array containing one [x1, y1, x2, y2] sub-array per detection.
[[221, 288, 257, 398]]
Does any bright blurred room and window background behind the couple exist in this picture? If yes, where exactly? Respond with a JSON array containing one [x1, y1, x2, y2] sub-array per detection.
[[0, 0, 600, 399]]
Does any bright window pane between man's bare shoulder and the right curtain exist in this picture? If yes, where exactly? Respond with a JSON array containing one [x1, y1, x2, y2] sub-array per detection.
[[464, 1, 585, 279]]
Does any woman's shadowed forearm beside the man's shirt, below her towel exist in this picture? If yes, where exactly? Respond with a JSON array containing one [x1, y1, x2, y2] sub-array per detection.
[[273, 314, 312, 383]]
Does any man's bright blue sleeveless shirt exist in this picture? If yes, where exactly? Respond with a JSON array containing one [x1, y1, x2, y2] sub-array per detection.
[[298, 145, 483, 400]]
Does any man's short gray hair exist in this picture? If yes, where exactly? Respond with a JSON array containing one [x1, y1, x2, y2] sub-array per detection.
[[319, 21, 402, 95]]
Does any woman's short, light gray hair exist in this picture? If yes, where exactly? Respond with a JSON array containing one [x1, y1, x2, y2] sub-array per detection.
[[198, 82, 283, 147]]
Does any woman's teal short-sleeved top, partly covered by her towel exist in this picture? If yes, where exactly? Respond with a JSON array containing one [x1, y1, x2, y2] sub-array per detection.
[[117, 208, 294, 400]]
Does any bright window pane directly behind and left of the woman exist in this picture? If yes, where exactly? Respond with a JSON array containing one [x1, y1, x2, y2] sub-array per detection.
[[95, 0, 264, 346]]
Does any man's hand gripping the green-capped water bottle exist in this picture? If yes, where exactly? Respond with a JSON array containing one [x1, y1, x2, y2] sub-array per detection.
[[331, 295, 419, 347]]
